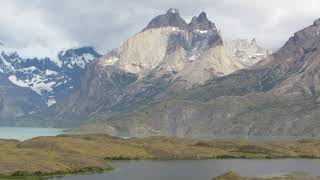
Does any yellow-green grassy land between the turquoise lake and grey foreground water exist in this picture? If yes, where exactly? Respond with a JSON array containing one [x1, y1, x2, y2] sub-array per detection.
[[0, 134, 320, 179]]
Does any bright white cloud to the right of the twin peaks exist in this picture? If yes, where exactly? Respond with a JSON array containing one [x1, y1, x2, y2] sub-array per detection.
[[208, 0, 320, 47]]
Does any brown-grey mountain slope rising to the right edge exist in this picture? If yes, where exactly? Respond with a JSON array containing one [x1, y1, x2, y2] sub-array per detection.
[[74, 17, 320, 137]]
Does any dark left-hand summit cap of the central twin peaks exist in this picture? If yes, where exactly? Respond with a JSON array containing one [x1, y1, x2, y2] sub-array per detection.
[[144, 8, 188, 31]]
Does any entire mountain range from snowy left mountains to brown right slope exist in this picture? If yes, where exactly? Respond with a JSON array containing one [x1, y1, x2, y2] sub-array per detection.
[[0, 9, 298, 137]]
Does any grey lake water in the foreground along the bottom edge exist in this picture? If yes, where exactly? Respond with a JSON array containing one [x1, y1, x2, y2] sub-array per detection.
[[53, 159, 320, 180]]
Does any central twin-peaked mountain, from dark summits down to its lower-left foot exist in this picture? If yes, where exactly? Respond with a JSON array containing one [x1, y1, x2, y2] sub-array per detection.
[[20, 9, 243, 126]]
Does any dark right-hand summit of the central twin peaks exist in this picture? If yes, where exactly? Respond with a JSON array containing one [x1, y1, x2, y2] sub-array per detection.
[[189, 12, 217, 32]]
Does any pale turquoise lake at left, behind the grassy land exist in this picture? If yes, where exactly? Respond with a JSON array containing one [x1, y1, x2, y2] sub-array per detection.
[[0, 127, 63, 141]]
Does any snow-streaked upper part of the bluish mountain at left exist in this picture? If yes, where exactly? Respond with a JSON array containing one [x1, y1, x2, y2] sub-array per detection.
[[0, 47, 101, 106]]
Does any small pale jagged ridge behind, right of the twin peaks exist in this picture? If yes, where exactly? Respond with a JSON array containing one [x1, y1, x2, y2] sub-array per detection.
[[224, 39, 272, 67]]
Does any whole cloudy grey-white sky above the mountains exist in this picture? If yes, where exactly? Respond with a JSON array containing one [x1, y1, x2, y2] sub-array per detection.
[[0, 0, 320, 57]]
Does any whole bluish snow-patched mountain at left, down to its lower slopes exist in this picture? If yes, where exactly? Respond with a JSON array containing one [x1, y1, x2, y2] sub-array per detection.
[[0, 46, 101, 123]]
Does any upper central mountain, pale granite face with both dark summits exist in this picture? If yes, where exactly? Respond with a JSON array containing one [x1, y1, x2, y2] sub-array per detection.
[[106, 8, 223, 75]]
